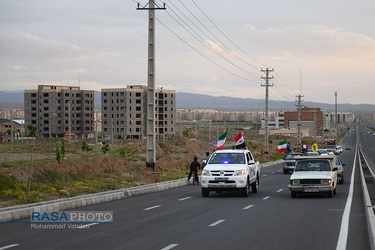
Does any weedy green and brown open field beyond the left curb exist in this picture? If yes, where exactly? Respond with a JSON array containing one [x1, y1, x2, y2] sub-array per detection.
[[0, 123, 345, 207]]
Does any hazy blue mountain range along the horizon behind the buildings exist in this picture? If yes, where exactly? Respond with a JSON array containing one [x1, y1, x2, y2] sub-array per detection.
[[0, 91, 375, 113]]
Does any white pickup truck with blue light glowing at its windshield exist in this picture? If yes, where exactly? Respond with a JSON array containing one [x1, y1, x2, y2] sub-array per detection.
[[201, 149, 260, 197]]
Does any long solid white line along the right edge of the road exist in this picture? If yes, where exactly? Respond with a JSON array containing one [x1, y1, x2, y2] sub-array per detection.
[[336, 149, 358, 250]]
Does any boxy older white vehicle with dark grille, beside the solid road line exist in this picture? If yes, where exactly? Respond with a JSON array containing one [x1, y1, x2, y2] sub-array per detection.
[[289, 155, 338, 198]]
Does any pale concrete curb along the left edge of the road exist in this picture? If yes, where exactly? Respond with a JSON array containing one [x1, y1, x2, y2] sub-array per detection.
[[0, 160, 282, 222]]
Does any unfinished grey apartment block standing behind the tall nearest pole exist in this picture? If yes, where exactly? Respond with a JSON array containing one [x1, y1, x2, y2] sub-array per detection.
[[101, 85, 176, 139]]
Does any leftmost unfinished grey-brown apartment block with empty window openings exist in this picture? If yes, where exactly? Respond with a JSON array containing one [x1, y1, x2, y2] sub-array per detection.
[[24, 85, 94, 137]]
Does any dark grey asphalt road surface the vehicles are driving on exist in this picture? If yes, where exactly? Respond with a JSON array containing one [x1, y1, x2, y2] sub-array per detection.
[[0, 123, 375, 250]]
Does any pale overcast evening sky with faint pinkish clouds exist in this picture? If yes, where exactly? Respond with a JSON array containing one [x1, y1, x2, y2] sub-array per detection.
[[0, 0, 375, 104]]
